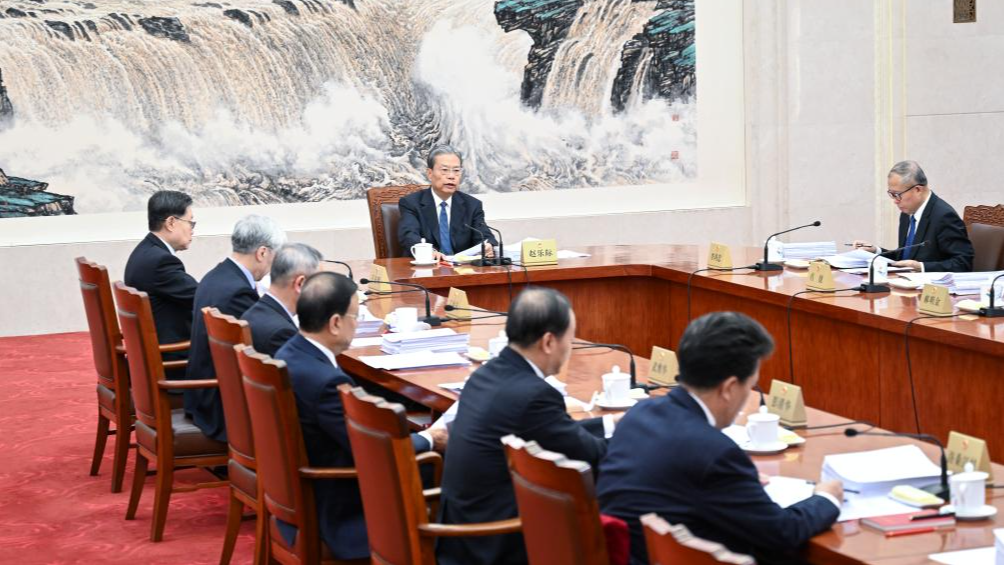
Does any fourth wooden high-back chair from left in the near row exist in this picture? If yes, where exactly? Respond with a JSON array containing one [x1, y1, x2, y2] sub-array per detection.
[[233, 345, 370, 565]]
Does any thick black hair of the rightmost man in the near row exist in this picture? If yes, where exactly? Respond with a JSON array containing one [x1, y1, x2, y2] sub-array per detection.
[[677, 312, 775, 390]]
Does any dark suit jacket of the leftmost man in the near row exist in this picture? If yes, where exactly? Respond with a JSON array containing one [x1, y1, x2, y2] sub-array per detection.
[[123, 233, 198, 343]]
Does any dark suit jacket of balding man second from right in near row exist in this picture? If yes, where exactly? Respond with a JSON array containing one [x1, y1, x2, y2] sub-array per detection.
[[436, 348, 607, 565]]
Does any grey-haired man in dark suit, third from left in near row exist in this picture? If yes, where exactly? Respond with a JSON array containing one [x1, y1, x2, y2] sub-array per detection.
[[241, 243, 322, 356]]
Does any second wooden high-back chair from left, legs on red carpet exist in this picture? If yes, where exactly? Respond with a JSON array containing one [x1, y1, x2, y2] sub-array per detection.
[[114, 283, 227, 542]]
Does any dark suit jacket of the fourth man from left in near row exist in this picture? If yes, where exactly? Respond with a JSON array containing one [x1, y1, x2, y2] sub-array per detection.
[[275, 334, 431, 559]]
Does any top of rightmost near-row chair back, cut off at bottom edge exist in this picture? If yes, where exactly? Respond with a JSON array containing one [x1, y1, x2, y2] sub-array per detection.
[[639, 514, 756, 565]]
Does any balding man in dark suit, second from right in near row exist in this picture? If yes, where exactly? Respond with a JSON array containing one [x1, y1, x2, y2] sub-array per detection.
[[436, 288, 613, 565]]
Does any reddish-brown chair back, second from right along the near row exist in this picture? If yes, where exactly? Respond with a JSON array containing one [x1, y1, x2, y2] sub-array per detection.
[[501, 435, 610, 565]]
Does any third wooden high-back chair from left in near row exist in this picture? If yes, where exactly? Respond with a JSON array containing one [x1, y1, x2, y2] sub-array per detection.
[[202, 307, 268, 565]]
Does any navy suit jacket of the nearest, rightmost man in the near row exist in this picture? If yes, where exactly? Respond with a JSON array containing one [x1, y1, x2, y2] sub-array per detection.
[[594, 387, 839, 565]]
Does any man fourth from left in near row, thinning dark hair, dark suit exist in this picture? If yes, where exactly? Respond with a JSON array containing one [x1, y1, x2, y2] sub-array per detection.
[[275, 272, 446, 559]]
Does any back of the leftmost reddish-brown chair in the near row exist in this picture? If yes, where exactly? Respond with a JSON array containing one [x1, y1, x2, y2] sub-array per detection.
[[75, 257, 125, 392]]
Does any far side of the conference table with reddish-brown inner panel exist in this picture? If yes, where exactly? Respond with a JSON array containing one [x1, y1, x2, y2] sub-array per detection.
[[354, 245, 1005, 462]]
